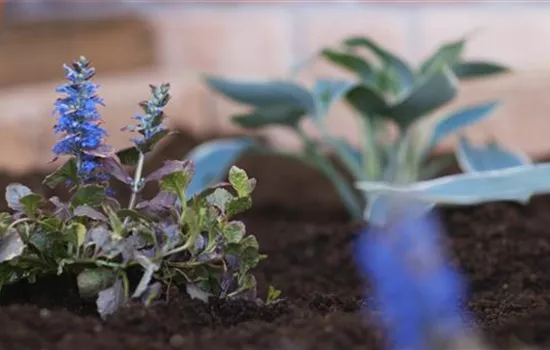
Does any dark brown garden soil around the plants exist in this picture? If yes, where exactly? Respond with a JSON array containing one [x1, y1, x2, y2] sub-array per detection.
[[0, 130, 550, 350]]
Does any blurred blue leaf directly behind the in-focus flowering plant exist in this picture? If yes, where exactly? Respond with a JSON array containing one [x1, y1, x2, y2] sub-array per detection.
[[186, 138, 253, 198]]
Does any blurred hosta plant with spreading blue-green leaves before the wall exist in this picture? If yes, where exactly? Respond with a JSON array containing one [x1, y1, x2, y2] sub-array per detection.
[[206, 37, 507, 218]]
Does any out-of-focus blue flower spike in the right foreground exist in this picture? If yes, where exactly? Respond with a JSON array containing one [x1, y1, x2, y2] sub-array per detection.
[[356, 200, 492, 350]]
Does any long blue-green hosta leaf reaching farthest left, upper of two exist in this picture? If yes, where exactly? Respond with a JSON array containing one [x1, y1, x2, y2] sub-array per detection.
[[205, 77, 314, 111]]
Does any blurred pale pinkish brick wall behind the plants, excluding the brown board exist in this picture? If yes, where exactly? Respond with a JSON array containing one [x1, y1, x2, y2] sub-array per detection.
[[0, 1, 550, 170]]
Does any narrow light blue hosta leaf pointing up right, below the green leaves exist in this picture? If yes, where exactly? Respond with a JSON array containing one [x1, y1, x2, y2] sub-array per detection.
[[430, 101, 500, 148]]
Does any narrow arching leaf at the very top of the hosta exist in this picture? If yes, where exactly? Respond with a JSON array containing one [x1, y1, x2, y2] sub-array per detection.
[[344, 37, 415, 92]]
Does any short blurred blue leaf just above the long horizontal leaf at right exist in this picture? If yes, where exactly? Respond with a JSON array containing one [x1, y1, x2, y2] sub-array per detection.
[[456, 137, 531, 172]]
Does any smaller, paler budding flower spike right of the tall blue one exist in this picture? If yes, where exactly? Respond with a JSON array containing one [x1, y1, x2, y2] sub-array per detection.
[[126, 83, 170, 153]]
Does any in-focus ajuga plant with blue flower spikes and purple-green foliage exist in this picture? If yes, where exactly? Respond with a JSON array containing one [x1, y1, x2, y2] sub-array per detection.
[[0, 57, 277, 317]]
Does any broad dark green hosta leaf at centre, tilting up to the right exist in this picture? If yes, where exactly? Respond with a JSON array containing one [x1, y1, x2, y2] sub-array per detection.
[[383, 67, 458, 130]]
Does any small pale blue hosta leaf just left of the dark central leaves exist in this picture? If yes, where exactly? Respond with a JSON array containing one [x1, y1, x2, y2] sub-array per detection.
[[310, 79, 355, 120]]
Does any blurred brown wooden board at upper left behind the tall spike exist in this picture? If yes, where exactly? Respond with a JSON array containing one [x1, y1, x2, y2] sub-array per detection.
[[0, 17, 155, 87]]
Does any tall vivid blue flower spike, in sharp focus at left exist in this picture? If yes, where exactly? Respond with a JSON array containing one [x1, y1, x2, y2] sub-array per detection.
[[53, 57, 107, 182]]
